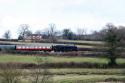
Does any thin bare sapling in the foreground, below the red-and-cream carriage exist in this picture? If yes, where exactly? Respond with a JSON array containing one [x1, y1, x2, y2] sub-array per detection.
[[33, 56, 53, 83]]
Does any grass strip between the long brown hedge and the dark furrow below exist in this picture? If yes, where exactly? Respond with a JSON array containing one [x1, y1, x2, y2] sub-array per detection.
[[23, 68, 125, 75]]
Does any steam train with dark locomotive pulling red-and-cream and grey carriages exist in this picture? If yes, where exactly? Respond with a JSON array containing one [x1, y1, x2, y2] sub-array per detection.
[[0, 45, 78, 52]]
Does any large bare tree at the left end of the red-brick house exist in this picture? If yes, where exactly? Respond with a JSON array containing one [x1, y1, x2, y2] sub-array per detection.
[[18, 24, 32, 40]]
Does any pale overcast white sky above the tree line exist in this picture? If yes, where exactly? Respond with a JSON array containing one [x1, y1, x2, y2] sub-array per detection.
[[0, 0, 125, 37]]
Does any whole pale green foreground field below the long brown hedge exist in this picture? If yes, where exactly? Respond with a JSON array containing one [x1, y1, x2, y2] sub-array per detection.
[[0, 68, 125, 83]]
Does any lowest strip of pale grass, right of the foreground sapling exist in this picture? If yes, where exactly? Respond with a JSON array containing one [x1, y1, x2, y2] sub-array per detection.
[[54, 75, 125, 83]]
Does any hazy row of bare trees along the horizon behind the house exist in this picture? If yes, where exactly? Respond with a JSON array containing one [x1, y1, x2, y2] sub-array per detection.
[[3, 23, 125, 42]]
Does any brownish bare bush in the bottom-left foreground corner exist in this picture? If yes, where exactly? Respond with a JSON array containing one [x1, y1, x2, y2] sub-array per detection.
[[0, 63, 22, 83]]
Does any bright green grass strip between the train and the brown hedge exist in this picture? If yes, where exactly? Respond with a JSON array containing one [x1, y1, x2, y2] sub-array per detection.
[[0, 54, 125, 64]]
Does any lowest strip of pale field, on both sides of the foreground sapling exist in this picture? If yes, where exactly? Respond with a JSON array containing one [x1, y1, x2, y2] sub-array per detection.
[[9, 75, 125, 83]]
